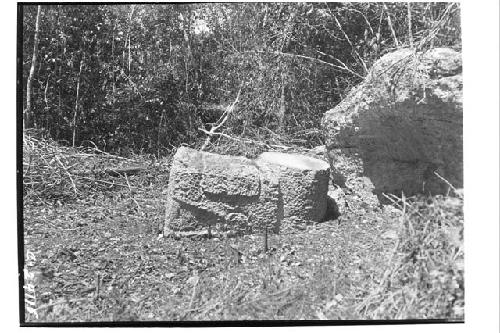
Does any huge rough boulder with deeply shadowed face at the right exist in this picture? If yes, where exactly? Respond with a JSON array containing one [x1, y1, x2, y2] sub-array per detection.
[[322, 48, 463, 195]]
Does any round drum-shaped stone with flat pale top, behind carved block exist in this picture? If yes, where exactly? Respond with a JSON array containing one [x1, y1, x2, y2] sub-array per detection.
[[256, 152, 330, 225]]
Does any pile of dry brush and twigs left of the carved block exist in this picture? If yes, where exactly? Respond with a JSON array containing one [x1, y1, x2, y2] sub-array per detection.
[[23, 130, 168, 202]]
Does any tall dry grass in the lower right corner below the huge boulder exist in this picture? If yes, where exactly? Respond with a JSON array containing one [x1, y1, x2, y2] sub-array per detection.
[[358, 192, 464, 320]]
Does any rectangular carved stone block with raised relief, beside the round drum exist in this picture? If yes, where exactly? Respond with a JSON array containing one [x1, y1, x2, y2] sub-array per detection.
[[165, 147, 283, 233]]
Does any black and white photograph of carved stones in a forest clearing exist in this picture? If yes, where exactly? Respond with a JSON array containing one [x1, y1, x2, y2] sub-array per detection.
[[13, 2, 498, 327]]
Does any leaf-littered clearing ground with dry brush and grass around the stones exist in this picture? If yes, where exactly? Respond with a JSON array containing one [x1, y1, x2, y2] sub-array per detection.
[[23, 131, 464, 322]]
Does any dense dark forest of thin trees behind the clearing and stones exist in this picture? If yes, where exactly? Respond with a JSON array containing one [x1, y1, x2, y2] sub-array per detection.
[[22, 2, 461, 157]]
